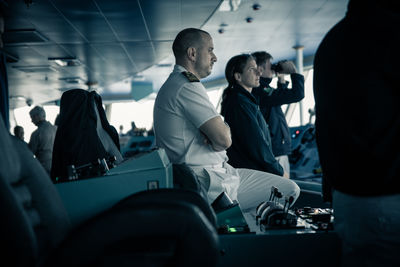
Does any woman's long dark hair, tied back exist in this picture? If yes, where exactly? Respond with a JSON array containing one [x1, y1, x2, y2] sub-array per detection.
[[221, 54, 254, 116]]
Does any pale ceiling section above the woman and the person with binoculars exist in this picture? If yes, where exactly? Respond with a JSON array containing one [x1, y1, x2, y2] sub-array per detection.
[[204, 0, 348, 81]]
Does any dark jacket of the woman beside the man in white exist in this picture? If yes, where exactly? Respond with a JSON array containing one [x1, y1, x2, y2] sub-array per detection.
[[221, 85, 283, 175]]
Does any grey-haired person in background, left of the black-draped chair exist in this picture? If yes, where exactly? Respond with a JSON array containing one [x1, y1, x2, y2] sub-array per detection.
[[28, 106, 57, 174]]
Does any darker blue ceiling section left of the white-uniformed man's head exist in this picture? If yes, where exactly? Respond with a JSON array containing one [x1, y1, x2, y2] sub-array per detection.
[[3, 0, 220, 109]]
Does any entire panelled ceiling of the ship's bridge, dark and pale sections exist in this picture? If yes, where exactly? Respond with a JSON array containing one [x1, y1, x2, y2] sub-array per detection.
[[0, 0, 348, 107]]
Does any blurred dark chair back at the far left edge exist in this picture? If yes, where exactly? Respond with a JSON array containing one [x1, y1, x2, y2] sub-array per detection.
[[0, 118, 70, 266]]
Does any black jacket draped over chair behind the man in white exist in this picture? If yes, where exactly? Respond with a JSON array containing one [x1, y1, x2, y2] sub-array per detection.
[[51, 89, 122, 181]]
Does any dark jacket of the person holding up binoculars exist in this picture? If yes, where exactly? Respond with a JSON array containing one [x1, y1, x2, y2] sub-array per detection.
[[252, 73, 304, 157]]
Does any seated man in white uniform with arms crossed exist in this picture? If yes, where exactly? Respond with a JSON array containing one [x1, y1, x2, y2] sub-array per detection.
[[154, 28, 300, 231]]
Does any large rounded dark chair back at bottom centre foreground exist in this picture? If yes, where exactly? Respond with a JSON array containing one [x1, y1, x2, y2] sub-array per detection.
[[49, 189, 219, 267]]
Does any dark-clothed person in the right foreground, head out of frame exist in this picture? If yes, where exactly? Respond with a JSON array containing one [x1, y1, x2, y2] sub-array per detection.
[[314, 0, 400, 267]]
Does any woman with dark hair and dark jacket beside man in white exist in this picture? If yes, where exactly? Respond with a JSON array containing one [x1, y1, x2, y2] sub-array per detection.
[[221, 54, 289, 177]]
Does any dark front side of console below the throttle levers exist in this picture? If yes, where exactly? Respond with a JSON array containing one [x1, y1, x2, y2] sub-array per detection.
[[218, 230, 341, 267]]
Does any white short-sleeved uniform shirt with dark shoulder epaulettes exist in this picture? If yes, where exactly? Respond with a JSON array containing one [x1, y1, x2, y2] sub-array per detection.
[[154, 65, 228, 167]]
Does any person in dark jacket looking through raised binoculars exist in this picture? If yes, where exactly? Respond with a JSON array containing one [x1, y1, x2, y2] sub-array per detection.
[[252, 51, 304, 177]]
